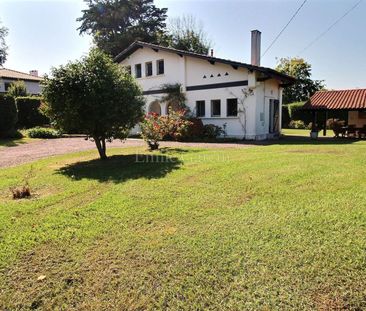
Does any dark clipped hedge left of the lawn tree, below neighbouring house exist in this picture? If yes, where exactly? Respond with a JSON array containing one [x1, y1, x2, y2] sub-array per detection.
[[16, 97, 50, 128]]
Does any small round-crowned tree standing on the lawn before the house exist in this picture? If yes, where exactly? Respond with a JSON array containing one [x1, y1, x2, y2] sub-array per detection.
[[42, 49, 144, 159]]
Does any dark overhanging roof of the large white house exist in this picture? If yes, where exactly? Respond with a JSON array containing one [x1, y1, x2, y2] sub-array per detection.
[[115, 41, 296, 85]]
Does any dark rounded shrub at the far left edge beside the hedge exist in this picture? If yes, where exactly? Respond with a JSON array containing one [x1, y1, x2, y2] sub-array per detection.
[[0, 94, 18, 137]]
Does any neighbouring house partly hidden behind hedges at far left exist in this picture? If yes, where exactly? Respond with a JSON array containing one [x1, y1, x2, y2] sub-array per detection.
[[0, 68, 42, 95]]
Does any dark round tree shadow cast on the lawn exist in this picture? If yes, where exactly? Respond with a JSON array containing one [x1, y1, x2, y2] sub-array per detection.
[[57, 153, 182, 183]]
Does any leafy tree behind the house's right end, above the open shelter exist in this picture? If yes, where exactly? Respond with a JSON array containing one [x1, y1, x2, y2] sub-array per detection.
[[276, 58, 324, 104]]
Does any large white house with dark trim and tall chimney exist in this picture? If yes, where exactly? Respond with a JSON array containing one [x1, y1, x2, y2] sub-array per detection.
[[115, 30, 294, 140]]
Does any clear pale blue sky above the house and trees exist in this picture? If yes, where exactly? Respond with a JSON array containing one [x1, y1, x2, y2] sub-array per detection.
[[0, 0, 366, 89]]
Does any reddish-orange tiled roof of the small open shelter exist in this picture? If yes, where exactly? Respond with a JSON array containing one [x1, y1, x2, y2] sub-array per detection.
[[303, 89, 366, 110]]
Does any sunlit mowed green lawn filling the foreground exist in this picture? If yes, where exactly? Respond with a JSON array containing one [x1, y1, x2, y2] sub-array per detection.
[[0, 140, 366, 310]]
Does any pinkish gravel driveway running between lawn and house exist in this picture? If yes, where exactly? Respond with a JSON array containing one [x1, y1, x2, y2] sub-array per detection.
[[0, 137, 250, 167]]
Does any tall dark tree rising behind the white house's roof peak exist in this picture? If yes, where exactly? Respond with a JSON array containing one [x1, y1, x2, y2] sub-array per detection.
[[77, 0, 167, 57]]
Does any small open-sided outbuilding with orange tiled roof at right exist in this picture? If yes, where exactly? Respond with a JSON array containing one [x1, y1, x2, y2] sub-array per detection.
[[303, 89, 366, 134]]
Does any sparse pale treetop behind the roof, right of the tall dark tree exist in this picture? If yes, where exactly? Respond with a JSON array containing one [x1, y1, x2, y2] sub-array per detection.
[[162, 15, 212, 54]]
